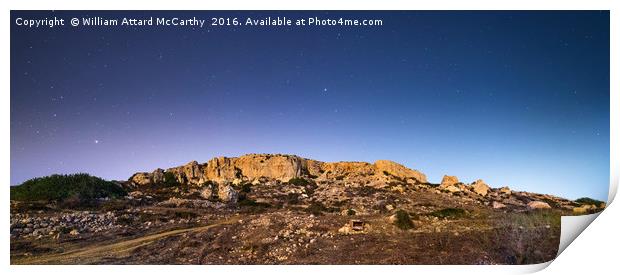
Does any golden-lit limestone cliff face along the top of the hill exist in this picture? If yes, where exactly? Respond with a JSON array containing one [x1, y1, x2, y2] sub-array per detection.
[[129, 154, 427, 185]]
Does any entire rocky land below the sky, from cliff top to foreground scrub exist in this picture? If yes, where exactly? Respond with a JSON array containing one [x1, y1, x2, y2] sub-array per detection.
[[11, 154, 605, 264]]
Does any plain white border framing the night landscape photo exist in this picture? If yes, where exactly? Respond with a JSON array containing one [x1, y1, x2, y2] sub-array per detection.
[[0, 0, 620, 274]]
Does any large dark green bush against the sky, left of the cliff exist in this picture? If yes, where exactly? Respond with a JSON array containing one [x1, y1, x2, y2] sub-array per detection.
[[10, 173, 127, 201]]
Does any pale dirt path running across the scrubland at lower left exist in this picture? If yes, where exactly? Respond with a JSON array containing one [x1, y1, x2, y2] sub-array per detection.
[[11, 217, 238, 265]]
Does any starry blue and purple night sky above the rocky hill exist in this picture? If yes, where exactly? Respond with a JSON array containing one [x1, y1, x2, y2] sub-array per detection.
[[10, 11, 610, 200]]
